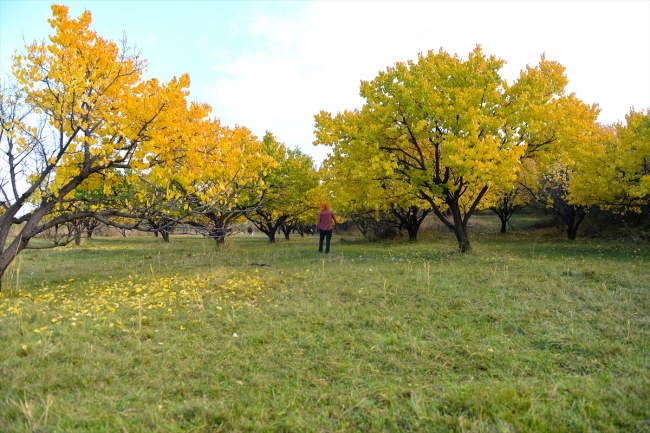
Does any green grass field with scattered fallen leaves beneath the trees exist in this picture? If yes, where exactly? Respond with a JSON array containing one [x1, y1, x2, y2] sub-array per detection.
[[0, 220, 650, 432]]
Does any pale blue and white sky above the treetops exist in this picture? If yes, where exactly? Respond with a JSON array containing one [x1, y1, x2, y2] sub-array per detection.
[[0, 0, 650, 163]]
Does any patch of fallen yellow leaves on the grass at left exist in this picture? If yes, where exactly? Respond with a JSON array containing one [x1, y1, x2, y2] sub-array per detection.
[[0, 273, 273, 332]]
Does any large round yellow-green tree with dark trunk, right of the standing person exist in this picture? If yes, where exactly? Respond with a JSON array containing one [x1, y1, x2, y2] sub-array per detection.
[[315, 46, 600, 252]]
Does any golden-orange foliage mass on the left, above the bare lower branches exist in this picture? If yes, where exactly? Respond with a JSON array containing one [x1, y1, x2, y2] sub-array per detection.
[[6, 5, 273, 212]]
